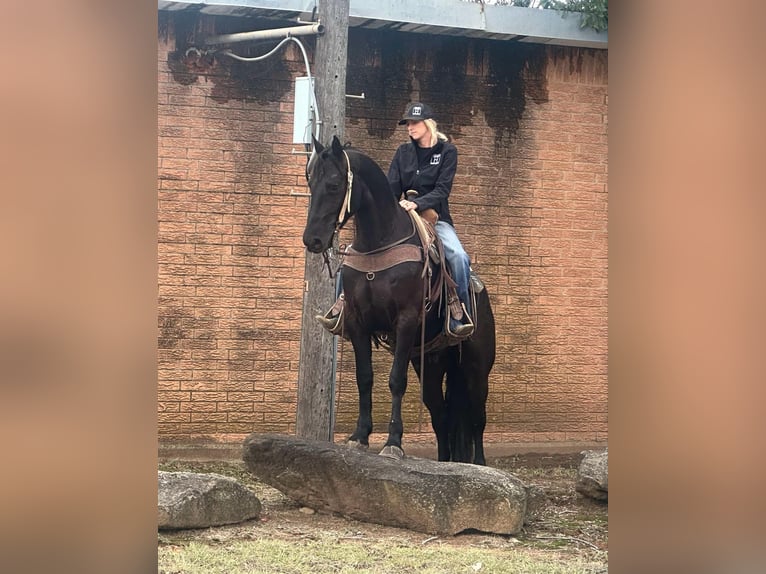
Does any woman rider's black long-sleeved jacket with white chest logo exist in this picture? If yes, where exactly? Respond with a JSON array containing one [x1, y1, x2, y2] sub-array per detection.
[[388, 140, 457, 225]]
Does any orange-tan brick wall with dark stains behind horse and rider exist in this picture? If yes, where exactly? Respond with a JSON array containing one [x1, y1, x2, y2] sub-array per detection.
[[158, 13, 607, 450]]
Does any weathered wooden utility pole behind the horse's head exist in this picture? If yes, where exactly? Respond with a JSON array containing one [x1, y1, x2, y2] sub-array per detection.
[[295, 0, 349, 441]]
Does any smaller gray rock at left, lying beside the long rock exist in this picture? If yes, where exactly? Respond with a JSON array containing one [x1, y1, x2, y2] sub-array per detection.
[[157, 470, 261, 530]]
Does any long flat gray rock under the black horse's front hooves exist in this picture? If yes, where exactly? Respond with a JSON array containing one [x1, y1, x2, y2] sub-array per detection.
[[244, 434, 527, 535]]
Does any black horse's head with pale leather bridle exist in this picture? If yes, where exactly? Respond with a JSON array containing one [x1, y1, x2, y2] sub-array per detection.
[[303, 136, 351, 253]]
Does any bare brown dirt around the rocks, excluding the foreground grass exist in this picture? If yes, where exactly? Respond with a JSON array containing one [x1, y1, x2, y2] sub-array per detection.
[[158, 453, 608, 572]]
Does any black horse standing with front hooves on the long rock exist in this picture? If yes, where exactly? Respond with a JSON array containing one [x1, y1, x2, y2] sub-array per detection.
[[303, 137, 495, 464]]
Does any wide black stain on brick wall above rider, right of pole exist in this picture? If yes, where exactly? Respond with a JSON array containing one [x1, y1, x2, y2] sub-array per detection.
[[346, 28, 548, 147]]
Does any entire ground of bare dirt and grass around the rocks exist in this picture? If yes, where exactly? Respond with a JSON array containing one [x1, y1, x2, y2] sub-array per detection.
[[158, 456, 608, 574]]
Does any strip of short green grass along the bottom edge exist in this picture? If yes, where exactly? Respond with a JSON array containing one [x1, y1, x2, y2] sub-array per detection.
[[158, 539, 603, 574]]
